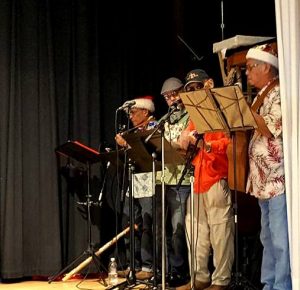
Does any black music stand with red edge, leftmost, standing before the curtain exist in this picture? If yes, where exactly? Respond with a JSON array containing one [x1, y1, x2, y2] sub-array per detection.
[[48, 141, 107, 286]]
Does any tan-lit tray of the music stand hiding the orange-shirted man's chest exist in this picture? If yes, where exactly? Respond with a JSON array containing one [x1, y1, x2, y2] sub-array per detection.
[[180, 86, 257, 134]]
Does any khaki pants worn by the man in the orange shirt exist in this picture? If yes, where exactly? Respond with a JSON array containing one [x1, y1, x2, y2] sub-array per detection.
[[186, 179, 234, 285]]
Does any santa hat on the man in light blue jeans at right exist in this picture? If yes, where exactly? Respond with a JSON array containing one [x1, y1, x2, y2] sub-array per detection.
[[246, 44, 278, 68]]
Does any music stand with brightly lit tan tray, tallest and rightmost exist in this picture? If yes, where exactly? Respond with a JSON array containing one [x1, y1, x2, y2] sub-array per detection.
[[180, 86, 257, 290]]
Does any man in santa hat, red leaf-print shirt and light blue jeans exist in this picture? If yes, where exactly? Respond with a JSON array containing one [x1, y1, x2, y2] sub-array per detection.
[[246, 44, 292, 290]]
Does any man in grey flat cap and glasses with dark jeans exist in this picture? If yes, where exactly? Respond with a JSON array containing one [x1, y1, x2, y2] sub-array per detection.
[[157, 77, 190, 287]]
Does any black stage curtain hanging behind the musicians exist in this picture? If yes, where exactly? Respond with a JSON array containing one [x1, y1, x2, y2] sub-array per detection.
[[0, 0, 276, 279]]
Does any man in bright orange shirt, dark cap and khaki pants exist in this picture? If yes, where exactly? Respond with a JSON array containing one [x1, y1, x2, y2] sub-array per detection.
[[180, 69, 234, 290]]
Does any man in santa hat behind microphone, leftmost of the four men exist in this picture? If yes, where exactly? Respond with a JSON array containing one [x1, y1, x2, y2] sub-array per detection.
[[115, 96, 157, 280]]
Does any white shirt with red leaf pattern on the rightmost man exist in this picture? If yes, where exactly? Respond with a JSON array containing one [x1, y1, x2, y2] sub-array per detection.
[[247, 80, 285, 199]]
